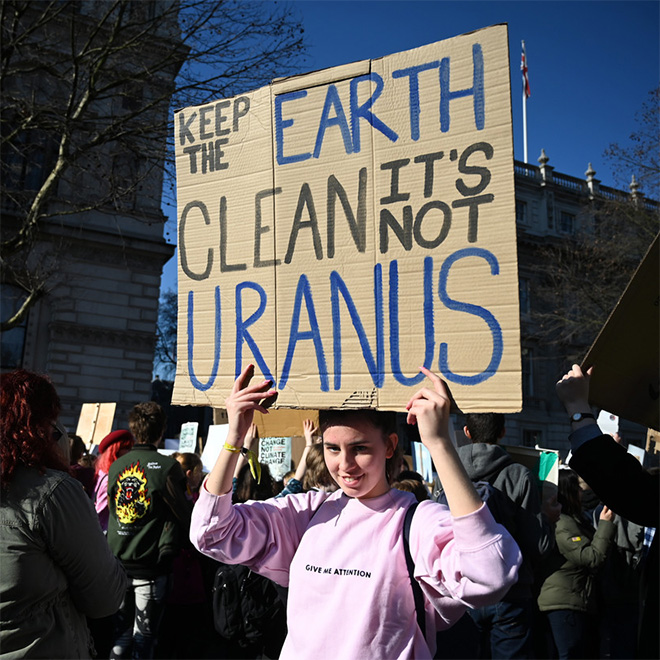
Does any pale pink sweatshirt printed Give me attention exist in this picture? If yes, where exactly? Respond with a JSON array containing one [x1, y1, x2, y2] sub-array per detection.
[[190, 487, 521, 660]]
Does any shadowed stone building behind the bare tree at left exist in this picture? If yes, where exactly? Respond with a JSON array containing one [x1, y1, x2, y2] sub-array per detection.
[[0, 0, 180, 431]]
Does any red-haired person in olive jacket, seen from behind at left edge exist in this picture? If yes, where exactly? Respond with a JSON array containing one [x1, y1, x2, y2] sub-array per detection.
[[0, 369, 126, 658]]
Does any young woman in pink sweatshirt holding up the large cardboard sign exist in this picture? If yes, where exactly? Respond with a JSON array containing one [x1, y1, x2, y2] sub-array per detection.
[[191, 366, 520, 659]]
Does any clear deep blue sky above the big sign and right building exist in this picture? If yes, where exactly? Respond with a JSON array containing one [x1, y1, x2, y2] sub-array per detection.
[[163, 0, 660, 289]]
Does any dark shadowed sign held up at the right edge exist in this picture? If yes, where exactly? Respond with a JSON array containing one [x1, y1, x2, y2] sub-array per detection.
[[582, 235, 660, 430]]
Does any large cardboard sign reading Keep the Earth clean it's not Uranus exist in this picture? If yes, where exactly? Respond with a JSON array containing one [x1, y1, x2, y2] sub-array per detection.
[[173, 25, 521, 412]]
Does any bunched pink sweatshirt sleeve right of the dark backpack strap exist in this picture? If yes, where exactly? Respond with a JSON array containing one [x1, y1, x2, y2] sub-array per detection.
[[410, 502, 522, 612]]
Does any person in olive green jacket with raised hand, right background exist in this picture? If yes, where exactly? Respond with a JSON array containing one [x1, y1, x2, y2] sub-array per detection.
[[538, 468, 616, 660]]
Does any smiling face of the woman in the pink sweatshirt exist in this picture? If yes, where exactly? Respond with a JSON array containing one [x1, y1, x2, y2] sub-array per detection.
[[323, 420, 398, 499]]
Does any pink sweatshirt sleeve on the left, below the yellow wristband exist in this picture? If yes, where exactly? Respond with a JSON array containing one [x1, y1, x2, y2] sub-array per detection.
[[190, 484, 327, 587]]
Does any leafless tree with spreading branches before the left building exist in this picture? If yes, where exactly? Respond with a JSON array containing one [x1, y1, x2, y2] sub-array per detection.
[[0, 0, 304, 330]]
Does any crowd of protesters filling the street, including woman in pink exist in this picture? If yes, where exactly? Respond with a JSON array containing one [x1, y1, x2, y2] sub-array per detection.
[[0, 366, 659, 660]]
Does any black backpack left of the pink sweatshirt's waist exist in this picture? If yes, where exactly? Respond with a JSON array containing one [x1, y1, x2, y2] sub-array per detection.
[[213, 563, 286, 647]]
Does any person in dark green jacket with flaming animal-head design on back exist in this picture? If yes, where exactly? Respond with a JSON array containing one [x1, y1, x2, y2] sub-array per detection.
[[108, 401, 192, 659]]
